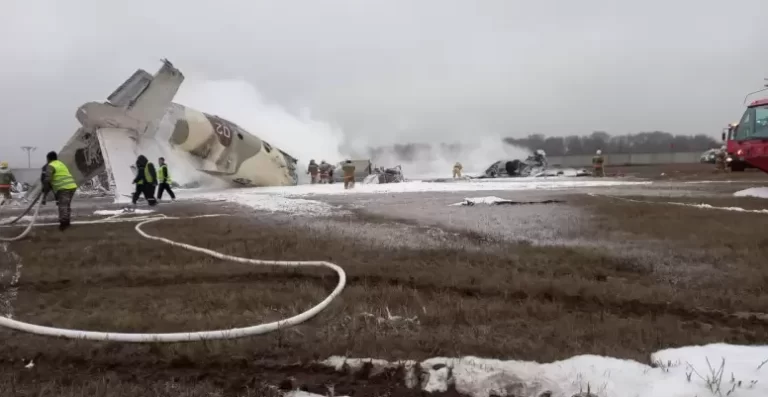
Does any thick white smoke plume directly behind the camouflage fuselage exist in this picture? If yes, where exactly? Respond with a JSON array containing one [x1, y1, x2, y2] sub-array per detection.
[[175, 79, 345, 183]]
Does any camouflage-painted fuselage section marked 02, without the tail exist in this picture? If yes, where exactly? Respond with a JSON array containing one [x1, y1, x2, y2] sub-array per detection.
[[155, 103, 298, 186]]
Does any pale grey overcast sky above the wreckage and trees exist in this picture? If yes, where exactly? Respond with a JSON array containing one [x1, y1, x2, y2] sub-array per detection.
[[0, 0, 768, 165]]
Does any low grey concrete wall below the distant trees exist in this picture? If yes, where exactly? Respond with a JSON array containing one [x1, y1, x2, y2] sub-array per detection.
[[547, 152, 703, 167]]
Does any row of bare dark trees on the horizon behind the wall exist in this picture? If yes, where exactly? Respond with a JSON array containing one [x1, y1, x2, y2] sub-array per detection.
[[504, 131, 721, 156]]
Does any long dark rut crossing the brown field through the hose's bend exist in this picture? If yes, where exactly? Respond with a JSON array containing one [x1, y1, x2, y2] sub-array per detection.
[[18, 272, 768, 331]]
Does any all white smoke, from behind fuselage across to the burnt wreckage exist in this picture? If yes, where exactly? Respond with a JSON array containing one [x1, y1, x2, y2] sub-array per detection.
[[176, 78, 529, 183]]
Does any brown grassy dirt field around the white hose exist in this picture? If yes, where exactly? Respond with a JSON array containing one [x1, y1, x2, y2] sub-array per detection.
[[0, 171, 768, 397]]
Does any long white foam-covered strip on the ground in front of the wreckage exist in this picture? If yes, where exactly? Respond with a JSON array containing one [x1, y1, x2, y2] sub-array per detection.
[[177, 177, 651, 216]]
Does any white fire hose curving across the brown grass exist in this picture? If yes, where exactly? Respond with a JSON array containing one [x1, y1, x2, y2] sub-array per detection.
[[0, 195, 347, 343]]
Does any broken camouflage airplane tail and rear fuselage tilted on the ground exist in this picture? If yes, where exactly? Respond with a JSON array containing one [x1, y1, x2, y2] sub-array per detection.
[[26, 60, 298, 202]]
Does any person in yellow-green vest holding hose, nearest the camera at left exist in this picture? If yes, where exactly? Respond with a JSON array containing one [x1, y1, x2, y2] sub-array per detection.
[[41, 152, 77, 231]]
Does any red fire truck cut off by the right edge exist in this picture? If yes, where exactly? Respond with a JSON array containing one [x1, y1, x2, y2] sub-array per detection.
[[722, 99, 768, 173]]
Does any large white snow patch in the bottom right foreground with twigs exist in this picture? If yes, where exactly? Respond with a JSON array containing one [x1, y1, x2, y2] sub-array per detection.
[[323, 344, 768, 397]]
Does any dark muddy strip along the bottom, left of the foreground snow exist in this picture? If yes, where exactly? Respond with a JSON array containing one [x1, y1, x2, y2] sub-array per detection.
[[0, 357, 463, 397]]
